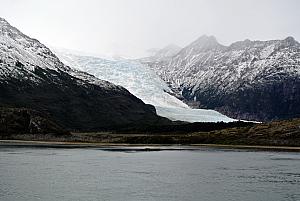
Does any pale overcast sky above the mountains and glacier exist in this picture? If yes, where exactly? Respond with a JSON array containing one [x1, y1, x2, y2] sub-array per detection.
[[0, 0, 300, 57]]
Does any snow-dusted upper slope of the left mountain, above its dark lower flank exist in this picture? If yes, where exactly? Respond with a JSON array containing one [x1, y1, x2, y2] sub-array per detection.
[[0, 18, 118, 89]]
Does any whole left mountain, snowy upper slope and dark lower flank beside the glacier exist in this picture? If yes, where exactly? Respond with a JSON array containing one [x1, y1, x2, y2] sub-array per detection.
[[0, 18, 169, 131]]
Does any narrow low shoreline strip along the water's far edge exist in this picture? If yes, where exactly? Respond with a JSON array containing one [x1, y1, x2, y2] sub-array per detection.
[[0, 140, 300, 152]]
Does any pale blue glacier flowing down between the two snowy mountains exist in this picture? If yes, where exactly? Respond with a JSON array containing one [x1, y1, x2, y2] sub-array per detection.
[[52, 48, 234, 122]]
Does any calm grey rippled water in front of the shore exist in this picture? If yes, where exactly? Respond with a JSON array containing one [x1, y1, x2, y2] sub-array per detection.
[[0, 147, 300, 201]]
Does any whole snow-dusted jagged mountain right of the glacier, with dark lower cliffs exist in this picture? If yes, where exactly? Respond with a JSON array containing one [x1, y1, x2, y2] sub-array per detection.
[[142, 36, 300, 121]]
